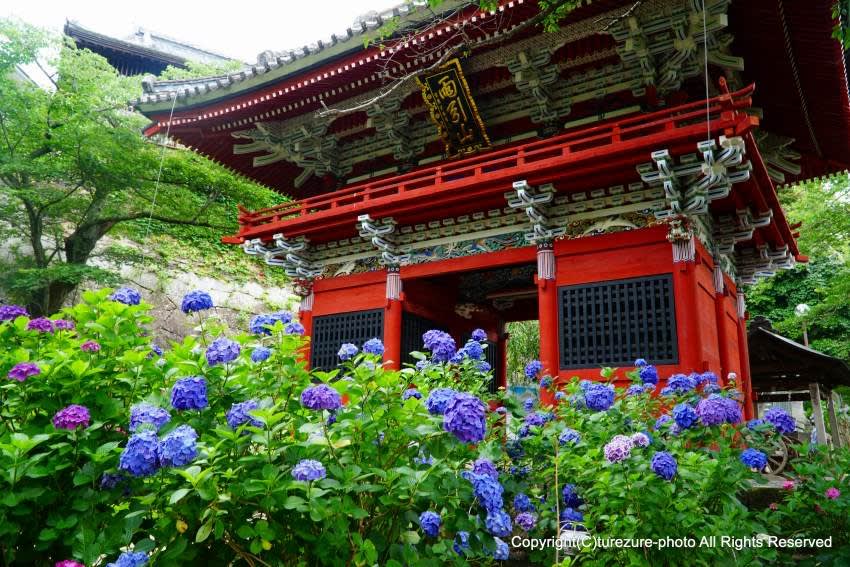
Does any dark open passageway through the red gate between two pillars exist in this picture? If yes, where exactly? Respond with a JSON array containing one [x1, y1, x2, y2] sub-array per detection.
[[401, 263, 538, 389]]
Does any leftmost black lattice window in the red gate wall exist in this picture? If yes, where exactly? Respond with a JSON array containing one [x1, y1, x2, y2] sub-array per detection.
[[310, 309, 384, 370]]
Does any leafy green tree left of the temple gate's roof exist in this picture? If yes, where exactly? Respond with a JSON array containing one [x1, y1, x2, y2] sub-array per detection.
[[0, 19, 281, 313]]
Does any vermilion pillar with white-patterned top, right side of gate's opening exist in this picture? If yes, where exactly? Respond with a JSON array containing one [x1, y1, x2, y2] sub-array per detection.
[[536, 240, 559, 404]]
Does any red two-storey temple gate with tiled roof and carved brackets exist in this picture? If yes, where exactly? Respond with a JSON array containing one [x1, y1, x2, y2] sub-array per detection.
[[135, 0, 850, 415]]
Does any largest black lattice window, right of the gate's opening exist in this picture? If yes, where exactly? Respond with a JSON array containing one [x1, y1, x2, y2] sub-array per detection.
[[558, 274, 678, 368]]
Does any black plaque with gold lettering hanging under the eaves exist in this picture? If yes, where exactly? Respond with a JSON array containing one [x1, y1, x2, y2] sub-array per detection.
[[416, 59, 490, 156]]
